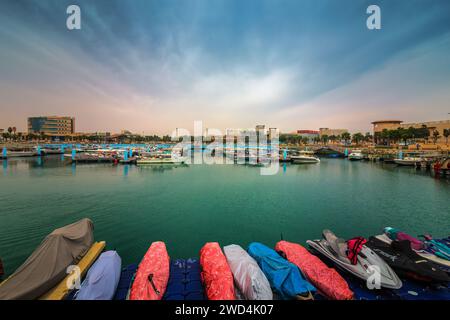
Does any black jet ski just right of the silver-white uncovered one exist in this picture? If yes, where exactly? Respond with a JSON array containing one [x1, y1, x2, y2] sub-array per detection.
[[366, 237, 450, 282]]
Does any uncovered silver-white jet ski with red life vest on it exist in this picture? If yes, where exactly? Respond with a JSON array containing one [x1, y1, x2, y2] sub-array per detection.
[[307, 230, 402, 289]]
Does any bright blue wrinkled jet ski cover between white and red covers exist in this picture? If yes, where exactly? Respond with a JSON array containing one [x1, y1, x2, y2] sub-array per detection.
[[248, 242, 316, 300]]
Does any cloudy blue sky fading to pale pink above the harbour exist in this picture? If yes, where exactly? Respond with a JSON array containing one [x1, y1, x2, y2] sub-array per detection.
[[0, 0, 450, 134]]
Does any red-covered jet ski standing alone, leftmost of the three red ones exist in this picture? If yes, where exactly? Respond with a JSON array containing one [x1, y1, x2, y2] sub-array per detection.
[[130, 241, 170, 300]]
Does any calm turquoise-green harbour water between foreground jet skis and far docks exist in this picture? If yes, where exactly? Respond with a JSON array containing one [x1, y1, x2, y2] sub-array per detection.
[[0, 157, 450, 273]]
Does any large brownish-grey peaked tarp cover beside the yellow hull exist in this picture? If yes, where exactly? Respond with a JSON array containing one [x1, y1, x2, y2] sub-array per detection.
[[0, 218, 94, 300]]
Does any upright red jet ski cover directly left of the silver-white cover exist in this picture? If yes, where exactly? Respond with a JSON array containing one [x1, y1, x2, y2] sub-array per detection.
[[200, 242, 236, 300]]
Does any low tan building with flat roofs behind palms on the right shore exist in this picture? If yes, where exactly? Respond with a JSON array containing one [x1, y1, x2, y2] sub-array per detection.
[[372, 120, 450, 143]]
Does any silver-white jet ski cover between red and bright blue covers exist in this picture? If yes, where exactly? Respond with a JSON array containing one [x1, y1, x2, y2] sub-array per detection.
[[223, 244, 273, 300]]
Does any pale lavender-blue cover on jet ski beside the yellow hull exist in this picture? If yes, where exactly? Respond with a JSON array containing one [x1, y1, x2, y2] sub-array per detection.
[[75, 251, 122, 300]]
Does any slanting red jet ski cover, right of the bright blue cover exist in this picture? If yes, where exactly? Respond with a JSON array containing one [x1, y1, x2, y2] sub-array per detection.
[[275, 241, 353, 300]]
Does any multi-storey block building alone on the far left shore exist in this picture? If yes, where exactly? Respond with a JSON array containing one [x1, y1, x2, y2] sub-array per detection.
[[28, 116, 75, 137]]
